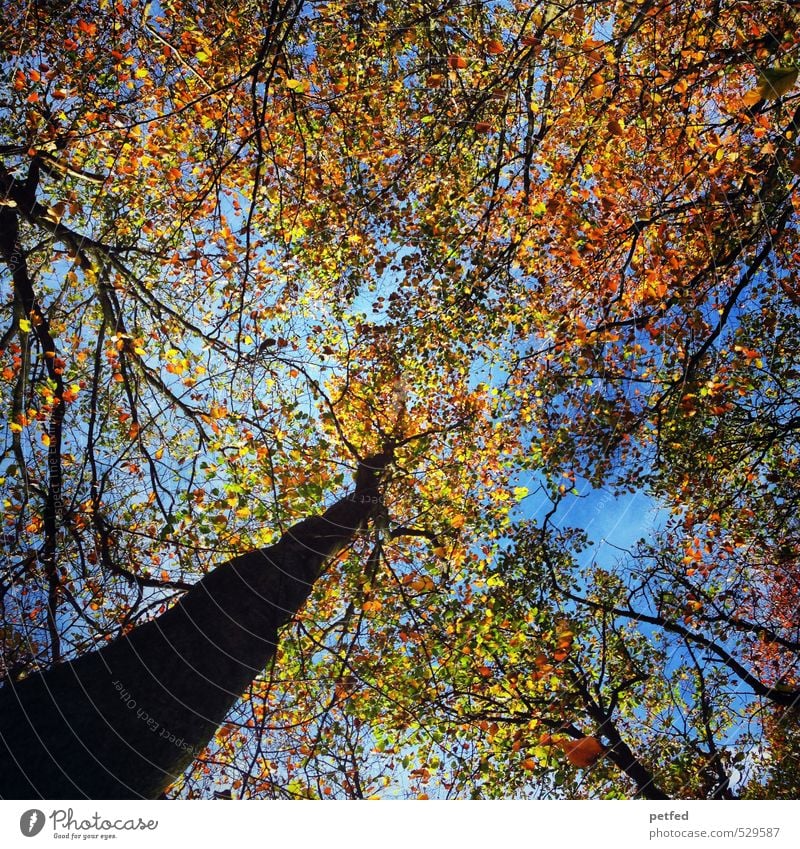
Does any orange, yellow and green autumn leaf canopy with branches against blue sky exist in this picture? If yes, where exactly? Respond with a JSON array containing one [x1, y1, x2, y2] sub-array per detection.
[[0, 0, 800, 798]]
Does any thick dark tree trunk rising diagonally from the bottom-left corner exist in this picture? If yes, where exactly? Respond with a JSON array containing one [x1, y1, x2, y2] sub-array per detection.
[[0, 455, 389, 799]]
